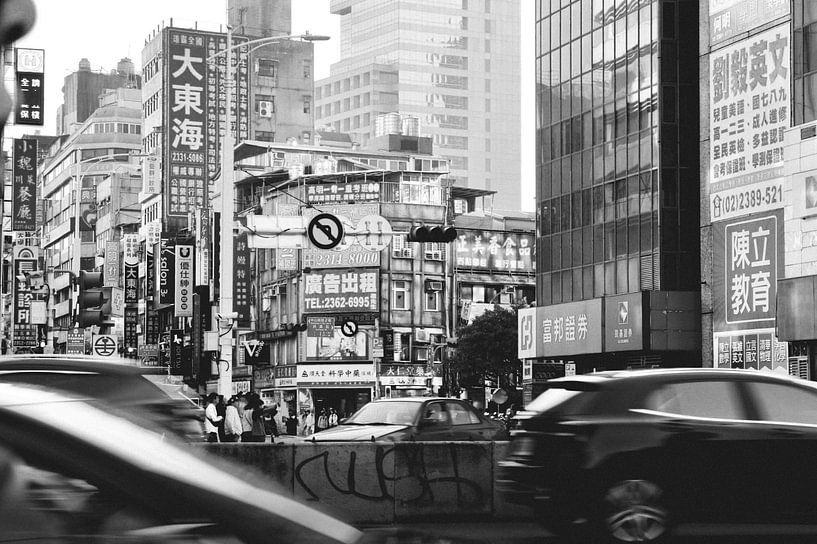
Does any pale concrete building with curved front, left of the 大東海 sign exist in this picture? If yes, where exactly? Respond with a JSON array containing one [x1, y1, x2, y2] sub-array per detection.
[[38, 88, 142, 352]]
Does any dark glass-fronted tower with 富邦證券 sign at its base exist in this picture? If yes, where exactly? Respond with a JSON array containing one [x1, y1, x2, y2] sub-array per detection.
[[520, 0, 700, 374]]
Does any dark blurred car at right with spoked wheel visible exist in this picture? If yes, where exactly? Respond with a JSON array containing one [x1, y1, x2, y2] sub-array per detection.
[[497, 369, 817, 542]]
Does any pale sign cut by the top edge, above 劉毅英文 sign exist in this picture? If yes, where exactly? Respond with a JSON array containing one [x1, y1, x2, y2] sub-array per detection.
[[709, 0, 789, 45]]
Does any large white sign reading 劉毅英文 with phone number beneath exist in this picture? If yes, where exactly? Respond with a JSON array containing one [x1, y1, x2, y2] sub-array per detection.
[[709, 24, 791, 197]]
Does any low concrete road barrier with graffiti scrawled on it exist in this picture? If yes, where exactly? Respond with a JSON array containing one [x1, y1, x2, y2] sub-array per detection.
[[203, 442, 531, 524]]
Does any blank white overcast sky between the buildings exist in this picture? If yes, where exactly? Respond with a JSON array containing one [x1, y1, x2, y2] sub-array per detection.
[[6, 0, 534, 210]]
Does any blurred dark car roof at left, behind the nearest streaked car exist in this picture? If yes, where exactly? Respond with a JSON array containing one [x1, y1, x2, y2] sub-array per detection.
[[0, 355, 204, 442]]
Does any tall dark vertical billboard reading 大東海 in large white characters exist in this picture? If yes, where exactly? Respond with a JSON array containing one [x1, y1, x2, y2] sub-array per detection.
[[164, 28, 249, 218]]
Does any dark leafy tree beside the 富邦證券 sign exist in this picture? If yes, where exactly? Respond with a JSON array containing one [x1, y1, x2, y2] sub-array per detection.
[[451, 306, 522, 390]]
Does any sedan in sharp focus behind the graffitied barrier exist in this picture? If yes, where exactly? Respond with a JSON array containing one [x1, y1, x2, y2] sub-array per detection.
[[307, 397, 508, 442]]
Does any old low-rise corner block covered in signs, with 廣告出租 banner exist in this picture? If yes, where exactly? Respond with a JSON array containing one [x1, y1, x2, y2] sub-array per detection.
[[234, 136, 534, 432]]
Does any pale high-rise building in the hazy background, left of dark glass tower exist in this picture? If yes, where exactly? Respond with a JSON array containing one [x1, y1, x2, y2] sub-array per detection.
[[315, 0, 521, 210]]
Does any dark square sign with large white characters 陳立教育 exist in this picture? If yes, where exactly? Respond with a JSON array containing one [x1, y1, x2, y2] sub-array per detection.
[[712, 209, 784, 332]]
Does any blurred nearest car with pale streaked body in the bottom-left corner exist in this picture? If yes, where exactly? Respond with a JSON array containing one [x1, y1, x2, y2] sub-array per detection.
[[0, 384, 362, 544]]
